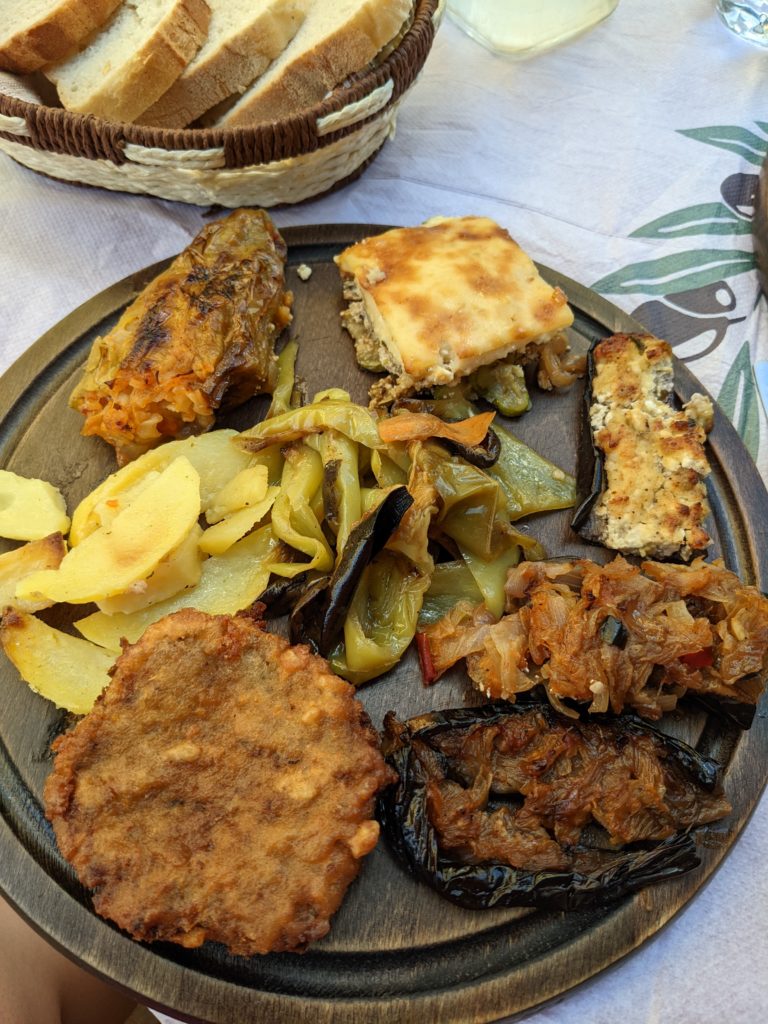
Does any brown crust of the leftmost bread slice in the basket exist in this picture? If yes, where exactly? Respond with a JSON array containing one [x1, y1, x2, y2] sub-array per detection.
[[0, 0, 122, 75]]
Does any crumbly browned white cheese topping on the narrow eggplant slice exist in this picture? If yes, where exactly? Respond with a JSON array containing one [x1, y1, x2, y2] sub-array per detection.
[[572, 334, 713, 561]]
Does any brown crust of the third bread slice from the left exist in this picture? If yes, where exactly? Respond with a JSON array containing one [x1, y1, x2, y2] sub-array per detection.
[[136, 0, 311, 128]]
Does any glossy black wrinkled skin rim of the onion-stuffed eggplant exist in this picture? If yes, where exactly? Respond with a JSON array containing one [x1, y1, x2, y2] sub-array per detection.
[[378, 700, 729, 910]]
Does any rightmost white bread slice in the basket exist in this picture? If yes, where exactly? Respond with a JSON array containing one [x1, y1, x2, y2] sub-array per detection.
[[216, 0, 413, 127]]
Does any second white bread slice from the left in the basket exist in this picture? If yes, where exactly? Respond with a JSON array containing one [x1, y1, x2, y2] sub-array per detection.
[[45, 0, 211, 121]]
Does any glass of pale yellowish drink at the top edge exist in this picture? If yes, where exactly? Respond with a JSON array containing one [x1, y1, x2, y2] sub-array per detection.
[[447, 0, 618, 57]]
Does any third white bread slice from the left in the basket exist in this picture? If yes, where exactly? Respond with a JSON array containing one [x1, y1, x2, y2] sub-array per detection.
[[136, 0, 312, 128]]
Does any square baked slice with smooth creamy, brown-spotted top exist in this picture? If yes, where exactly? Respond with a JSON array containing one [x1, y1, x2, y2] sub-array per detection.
[[336, 217, 573, 404]]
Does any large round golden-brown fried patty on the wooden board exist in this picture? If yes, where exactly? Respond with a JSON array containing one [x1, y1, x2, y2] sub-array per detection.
[[45, 609, 391, 955]]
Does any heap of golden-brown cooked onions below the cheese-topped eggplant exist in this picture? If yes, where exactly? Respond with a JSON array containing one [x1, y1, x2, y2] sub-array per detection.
[[422, 557, 768, 726]]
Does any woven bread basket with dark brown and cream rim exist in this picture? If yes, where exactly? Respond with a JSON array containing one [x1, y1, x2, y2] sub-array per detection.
[[0, 0, 444, 207]]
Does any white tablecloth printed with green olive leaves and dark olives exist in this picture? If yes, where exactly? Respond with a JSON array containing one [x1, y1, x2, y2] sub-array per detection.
[[0, 0, 768, 1024]]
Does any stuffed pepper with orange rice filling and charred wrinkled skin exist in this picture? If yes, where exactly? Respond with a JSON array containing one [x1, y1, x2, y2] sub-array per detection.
[[70, 210, 292, 466]]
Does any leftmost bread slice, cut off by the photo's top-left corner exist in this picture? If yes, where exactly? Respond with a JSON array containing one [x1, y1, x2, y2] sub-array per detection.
[[0, 0, 121, 75]]
